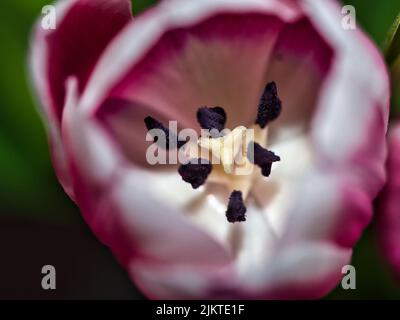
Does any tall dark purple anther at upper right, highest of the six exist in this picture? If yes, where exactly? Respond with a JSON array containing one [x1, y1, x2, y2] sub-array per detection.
[[256, 82, 282, 129]]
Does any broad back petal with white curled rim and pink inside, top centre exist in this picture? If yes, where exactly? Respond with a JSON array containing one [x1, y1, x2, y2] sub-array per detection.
[[82, 0, 298, 112]]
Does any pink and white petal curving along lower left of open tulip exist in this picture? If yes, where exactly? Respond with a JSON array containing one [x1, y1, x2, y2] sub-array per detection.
[[63, 92, 231, 267]]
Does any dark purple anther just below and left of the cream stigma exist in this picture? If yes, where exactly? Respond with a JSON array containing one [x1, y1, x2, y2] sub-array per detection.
[[178, 159, 212, 189]]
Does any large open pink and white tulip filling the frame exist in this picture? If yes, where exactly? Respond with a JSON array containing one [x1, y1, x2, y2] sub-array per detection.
[[30, 0, 389, 299]]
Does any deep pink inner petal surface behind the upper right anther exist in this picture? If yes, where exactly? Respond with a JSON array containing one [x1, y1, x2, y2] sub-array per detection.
[[266, 19, 333, 141]]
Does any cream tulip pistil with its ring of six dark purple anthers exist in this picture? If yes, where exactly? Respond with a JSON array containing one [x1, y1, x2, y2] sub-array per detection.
[[145, 82, 282, 223]]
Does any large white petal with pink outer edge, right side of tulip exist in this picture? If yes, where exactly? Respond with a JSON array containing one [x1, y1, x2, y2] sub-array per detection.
[[234, 0, 389, 294]]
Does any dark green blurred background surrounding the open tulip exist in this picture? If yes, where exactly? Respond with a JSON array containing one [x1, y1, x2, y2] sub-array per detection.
[[0, 0, 400, 299]]
